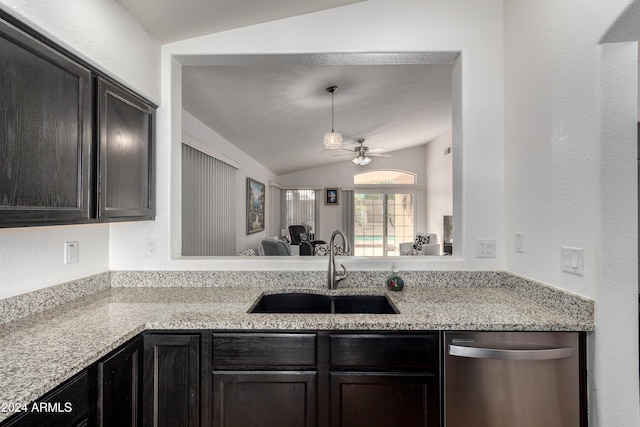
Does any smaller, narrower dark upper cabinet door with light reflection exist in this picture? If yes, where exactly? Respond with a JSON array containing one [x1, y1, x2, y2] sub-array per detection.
[[97, 78, 155, 220]]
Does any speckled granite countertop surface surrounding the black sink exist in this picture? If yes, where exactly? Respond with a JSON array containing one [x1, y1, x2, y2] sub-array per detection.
[[0, 273, 594, 420]]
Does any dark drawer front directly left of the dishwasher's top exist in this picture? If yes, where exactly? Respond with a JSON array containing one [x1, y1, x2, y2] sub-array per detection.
[[330, 333, 438, 370]]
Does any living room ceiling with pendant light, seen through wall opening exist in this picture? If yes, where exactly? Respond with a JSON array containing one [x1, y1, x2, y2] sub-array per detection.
[[182, 61, 452, 175]]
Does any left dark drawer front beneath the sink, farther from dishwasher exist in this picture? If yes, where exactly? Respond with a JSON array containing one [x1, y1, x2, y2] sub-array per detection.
[[213, 333, 316, 369]]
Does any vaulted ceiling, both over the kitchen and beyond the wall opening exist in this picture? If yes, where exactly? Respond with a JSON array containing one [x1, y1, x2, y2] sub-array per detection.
[[118, 0, 453, 175]]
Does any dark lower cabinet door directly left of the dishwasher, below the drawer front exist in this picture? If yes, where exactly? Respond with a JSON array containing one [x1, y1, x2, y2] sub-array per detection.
[[331, 372, 440, 427]]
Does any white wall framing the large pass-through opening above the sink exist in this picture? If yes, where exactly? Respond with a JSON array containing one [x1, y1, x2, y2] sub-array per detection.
[[111, 0, 504, 270]]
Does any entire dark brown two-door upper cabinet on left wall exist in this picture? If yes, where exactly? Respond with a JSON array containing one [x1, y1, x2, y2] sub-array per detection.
[[0, 10, 156, 228]]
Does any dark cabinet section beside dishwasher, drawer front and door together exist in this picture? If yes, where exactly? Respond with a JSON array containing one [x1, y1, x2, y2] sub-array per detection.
[[329, 332, 440, 427]]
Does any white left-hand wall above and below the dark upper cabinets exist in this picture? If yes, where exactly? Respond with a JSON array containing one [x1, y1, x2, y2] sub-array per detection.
[[0, 0, 160, 298]]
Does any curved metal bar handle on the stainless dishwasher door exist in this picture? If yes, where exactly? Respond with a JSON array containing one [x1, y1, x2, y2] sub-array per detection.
[[449, 344, 573, 360]]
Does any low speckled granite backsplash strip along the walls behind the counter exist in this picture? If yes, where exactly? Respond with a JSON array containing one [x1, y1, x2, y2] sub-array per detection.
[[0, 270, 594, 324]]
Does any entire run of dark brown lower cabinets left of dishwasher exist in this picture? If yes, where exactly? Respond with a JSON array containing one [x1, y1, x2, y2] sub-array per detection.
[[1, 331, 440, 427]]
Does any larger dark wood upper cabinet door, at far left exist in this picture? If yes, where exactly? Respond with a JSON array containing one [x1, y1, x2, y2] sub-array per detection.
[[0, 21, 93, 227]]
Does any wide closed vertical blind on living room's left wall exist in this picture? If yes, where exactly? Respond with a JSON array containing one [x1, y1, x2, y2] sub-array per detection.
[[182, 144, 236, 256]]
